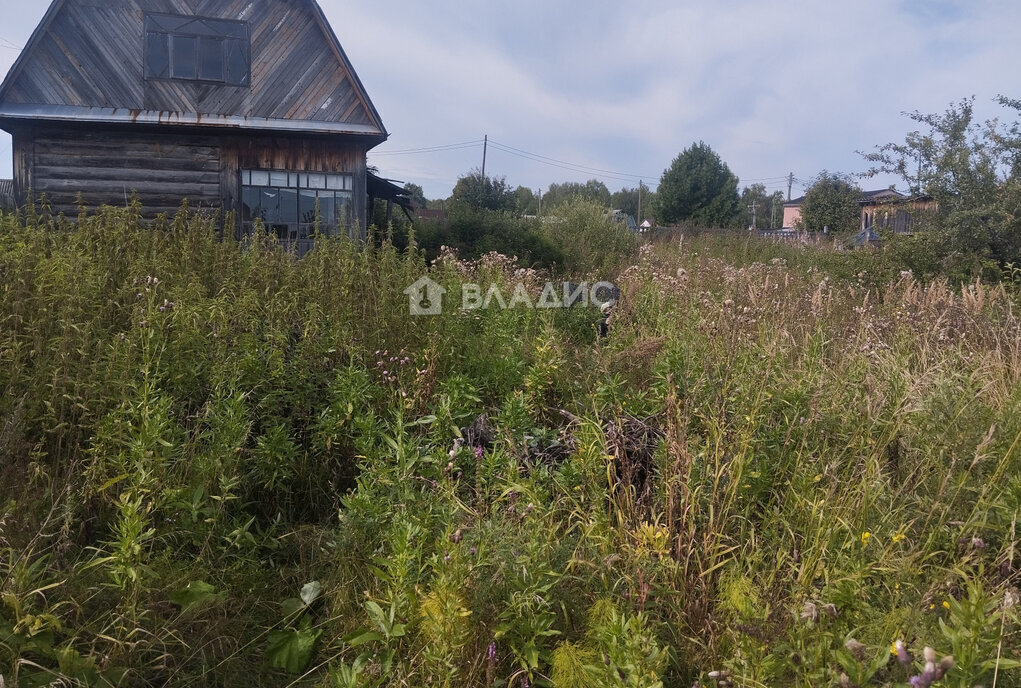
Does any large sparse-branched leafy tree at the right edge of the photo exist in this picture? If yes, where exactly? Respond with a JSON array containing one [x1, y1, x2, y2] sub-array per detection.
[[862, 96, 1021, 279]]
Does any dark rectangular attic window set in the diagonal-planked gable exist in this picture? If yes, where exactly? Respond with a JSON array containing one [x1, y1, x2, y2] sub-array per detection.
[[145, 14, 251, 86]]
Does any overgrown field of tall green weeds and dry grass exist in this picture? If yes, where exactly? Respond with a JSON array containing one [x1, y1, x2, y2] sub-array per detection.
[[0, 208, 1021, 687]]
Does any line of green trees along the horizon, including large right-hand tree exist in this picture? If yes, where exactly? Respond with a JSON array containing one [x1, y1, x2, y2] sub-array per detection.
[[392, 96, 1021, 279]]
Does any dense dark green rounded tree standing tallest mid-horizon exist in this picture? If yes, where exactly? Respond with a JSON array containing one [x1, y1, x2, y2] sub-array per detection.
[[655, 141, 740, 228]]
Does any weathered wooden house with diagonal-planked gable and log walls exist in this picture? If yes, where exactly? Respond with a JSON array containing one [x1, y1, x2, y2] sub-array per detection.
[[0, 0, 387, 251]]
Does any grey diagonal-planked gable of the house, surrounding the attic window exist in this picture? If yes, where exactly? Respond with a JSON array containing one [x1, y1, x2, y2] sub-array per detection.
[[0, 0, 388, 140]]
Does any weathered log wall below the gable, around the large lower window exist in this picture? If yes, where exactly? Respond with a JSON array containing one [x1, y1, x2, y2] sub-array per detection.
[[15, 121, 366, 230]]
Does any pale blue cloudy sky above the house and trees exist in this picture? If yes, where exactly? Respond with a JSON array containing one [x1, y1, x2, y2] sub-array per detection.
[[0, 0, 1021, 198]]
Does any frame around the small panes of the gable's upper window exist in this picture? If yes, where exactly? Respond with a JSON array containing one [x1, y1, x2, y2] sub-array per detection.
[[142, 12, 252, 89]]
